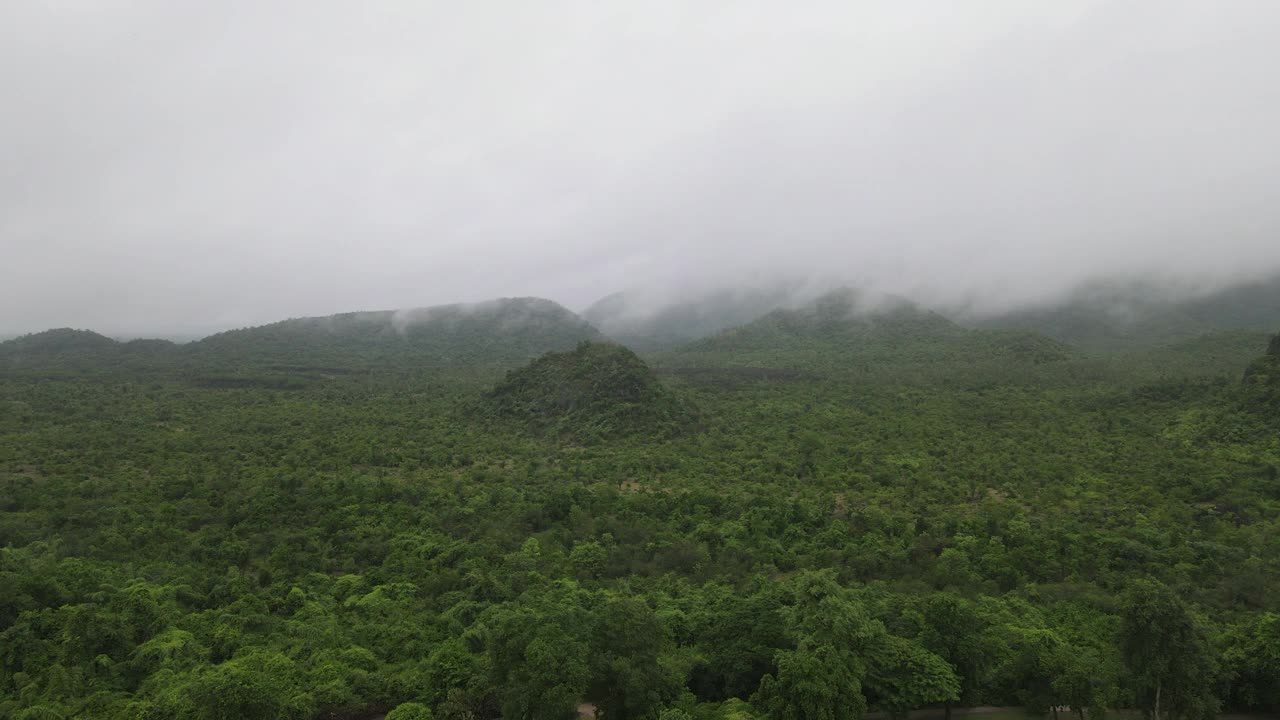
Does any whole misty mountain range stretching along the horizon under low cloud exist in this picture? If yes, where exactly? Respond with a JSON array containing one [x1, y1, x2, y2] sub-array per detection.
[[0, 278, 1280, 373]]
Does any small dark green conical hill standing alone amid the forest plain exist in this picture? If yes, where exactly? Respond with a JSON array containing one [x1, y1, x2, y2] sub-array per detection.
[[479, 342, 691, 442]]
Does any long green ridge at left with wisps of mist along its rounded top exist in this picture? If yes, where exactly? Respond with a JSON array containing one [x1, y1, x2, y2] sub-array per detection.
[[0, 297, 600, 379]]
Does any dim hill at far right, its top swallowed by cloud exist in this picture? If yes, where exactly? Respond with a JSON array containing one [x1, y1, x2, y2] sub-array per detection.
[[974, 271, 1280, 351]]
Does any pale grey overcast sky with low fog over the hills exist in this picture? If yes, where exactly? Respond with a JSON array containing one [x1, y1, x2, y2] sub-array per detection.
[[0, 0, 1280, 334]]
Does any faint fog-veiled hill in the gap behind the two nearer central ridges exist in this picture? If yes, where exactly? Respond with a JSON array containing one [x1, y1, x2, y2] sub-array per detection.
[[582, 286, 792, 351]]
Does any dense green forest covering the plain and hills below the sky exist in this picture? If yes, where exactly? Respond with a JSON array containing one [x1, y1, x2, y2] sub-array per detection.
[[0, 291, 1280, 720]]
